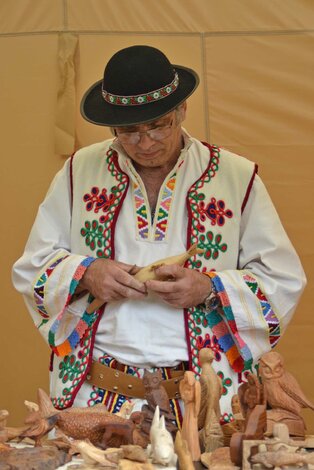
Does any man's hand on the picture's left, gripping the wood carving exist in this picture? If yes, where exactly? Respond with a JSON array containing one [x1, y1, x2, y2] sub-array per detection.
[[78, 258, 146, 303]]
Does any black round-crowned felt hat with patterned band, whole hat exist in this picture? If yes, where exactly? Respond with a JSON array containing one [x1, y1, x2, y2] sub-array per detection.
[[81, 46, 199, 127]]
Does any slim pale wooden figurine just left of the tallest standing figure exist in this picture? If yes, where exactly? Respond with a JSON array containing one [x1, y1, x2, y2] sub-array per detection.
[[179, 371, 201, 462]]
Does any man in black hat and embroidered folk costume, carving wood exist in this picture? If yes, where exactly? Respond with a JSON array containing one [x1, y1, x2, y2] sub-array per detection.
[[13, 46, 305, 420]]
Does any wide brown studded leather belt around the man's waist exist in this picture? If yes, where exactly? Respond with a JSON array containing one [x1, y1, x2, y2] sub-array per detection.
[[86, 362, 185, 399]]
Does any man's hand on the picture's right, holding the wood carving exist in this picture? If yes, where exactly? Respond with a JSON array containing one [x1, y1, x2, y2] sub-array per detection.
[[145, 264, 212, 308]]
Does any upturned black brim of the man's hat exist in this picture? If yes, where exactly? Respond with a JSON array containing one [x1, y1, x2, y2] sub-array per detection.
[[81, 65, 199, 127]]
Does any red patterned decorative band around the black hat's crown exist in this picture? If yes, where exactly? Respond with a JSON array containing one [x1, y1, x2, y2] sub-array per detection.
[[101, 72, 179, 106]]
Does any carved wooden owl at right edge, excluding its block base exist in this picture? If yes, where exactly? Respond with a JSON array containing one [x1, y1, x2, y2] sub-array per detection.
[[259, 351, 314, 416]]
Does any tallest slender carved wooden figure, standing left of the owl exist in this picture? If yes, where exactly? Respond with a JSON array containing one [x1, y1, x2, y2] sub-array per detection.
[[198, 348, 224, 452]]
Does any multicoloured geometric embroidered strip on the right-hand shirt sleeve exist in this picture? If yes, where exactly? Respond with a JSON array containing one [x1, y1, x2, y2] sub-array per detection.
[[243, 274, 281, 348]]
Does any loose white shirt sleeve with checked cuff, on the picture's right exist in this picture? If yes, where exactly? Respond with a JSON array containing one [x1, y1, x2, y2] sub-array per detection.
[[207, 175, 306, 371]]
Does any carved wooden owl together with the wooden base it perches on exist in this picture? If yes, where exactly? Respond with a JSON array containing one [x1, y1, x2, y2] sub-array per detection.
[[259, 351, 314, 438]]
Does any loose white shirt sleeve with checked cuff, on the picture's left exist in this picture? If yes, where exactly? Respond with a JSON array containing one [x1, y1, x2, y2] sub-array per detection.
[[12, 160, 95, 356]]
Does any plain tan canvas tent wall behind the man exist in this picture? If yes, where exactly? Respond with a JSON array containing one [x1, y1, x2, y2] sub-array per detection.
[[0, 0, 314, 433]]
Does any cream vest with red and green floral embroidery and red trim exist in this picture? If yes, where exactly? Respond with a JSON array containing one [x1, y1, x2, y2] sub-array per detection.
[[51, 139, 256, 409]]
